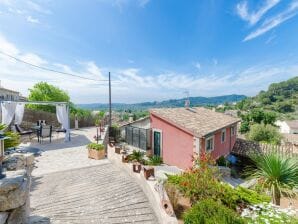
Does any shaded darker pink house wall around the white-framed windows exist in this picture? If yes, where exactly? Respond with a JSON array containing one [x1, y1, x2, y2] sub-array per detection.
[[202, 125, 236, 159]]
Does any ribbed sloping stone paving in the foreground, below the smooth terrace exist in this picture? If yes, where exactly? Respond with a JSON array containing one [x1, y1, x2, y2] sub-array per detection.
[[30, 163, 157, 224]]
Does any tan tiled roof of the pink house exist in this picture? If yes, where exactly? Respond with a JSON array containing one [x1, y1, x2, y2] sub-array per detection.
[[150, 107, 240, 137]]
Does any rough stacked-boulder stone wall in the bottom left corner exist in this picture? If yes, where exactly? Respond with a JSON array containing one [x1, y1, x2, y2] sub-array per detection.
[[0, 153, 34, 224]]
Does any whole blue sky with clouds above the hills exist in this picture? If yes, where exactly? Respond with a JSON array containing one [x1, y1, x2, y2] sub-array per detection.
[[0, 0, 298, 103]]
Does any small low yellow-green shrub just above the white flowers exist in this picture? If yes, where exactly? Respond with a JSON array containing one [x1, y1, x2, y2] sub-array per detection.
[[235, 187, 271, 205]]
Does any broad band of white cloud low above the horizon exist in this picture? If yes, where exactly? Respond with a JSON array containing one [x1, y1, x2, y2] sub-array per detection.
[[0, 35, 298, 103]]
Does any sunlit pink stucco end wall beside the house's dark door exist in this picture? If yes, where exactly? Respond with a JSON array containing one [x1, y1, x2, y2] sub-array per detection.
[[150, 114, 194, 169]]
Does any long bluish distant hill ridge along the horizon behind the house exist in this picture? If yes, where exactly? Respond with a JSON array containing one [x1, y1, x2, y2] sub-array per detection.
[[77, 94, 246, 110]]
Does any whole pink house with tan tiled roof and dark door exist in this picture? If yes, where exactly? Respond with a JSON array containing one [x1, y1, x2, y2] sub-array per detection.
[[150, 107, 239, 169]]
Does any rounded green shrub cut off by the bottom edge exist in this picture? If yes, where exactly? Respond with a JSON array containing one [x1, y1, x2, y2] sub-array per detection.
[[183, 199, 245, 224]]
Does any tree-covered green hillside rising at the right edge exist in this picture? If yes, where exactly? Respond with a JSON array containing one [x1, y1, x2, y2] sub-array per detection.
[[237, 76, 298, 119]]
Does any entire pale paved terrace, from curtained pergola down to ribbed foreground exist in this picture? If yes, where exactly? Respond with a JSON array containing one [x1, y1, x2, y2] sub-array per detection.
[[25, 128, 157, 224]]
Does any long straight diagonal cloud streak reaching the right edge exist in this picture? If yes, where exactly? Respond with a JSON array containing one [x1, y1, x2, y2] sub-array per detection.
[[243, 1, 298, 41]]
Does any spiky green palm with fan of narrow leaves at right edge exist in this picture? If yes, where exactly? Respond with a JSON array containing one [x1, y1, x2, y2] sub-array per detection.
[[248, 152, 298, 205]]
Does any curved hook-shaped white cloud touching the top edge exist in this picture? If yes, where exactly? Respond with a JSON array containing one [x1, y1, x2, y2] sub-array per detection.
[[236, 0, 280, 25]]
